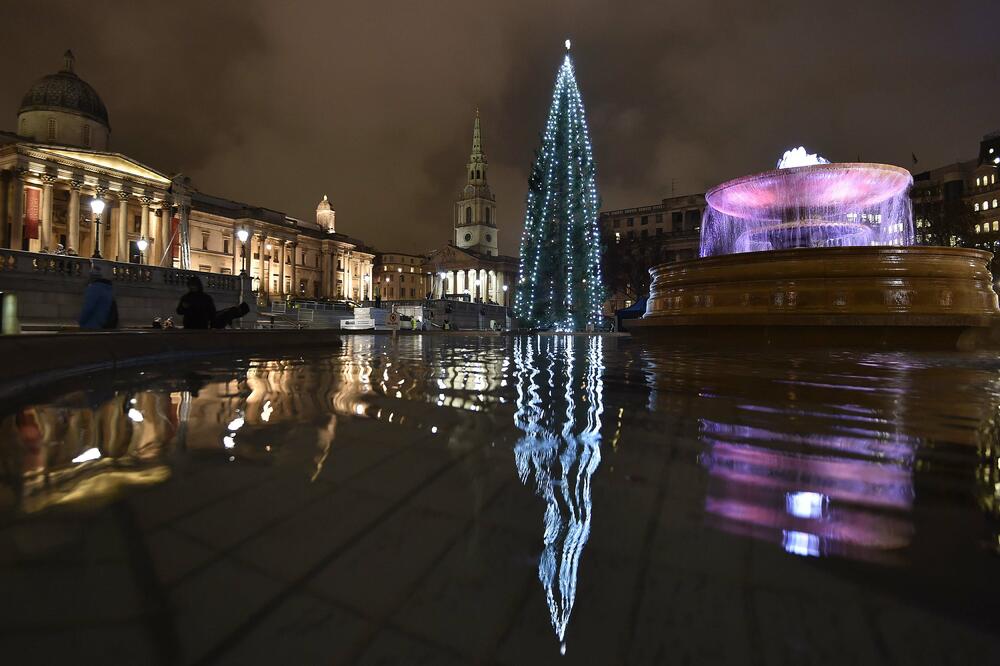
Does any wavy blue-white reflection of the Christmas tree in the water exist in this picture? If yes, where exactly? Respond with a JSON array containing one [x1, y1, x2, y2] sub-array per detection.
[[514, 338, 604, 650]]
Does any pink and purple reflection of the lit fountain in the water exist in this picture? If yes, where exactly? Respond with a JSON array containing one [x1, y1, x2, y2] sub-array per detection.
[[702, 420, 917, 559]]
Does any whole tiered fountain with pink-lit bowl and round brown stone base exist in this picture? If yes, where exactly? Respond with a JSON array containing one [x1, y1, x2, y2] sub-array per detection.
[[628, 148, 1000, 349]]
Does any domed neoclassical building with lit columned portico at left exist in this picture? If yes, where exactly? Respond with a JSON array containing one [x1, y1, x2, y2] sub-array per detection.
[[0, 51, 375, 301]]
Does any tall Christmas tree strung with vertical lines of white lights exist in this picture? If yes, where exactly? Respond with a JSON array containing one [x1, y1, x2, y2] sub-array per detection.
[[514, 40, 604, 331]]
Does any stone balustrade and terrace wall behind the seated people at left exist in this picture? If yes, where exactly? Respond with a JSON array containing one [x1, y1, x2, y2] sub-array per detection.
[[0, 249, 256, 328]]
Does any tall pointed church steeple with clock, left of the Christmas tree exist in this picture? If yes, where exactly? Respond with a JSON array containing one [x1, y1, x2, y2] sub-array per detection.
[[455, 109, 497, 257]]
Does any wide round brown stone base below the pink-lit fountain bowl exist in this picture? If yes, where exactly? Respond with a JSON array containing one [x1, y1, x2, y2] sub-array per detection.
[[628, 247, 1000, 349]]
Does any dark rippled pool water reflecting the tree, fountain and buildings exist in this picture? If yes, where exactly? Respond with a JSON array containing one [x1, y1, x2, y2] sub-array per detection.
[[0, 335, 1000, 664]]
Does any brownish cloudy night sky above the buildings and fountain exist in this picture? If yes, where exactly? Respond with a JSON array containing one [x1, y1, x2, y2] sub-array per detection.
[[0, 0, 1000, 254]]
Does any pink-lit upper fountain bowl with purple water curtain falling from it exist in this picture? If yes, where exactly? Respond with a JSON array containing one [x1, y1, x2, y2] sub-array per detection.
[[701, 163, 913, 257]]
